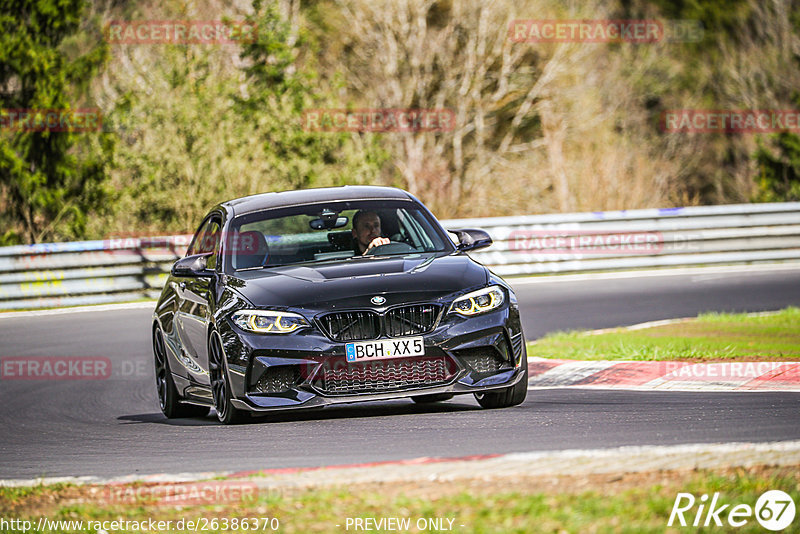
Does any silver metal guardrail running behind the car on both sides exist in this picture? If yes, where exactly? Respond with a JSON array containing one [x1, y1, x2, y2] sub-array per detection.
[[0, 202, 800, 309]]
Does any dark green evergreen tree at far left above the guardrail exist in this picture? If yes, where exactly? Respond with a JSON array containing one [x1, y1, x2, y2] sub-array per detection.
[[0, 0, 113, 244]]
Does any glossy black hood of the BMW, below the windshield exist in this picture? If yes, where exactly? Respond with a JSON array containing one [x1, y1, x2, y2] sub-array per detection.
[[228, 254, 488, 311]]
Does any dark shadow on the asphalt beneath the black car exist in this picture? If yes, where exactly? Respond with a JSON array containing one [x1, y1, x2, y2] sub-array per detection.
[[117, 396, 481, 426]]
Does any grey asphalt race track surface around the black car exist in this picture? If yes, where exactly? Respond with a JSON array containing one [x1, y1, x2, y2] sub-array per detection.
[[0, 267, 800, 479]]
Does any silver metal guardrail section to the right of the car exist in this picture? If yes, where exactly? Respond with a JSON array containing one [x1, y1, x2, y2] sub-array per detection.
[[454, 202, 800, 276]]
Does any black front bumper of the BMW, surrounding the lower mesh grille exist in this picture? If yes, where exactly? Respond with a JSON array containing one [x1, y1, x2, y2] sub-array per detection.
[[221, 306, 527, 412]]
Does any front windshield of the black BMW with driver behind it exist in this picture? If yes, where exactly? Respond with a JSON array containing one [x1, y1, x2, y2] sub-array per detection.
[[227, 200, 452, 270]]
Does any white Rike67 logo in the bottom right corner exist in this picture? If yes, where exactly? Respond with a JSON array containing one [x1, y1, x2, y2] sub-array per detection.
[[667, 490, 796, 532]]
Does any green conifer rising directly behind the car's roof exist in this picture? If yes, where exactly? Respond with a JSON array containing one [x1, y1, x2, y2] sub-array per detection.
[[238, 0, 386, 193]]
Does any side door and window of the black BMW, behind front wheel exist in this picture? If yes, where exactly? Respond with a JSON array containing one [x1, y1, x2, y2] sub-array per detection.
[[175, 214, 221, 384]]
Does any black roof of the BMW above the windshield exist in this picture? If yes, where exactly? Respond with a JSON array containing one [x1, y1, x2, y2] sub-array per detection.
[[220, 185, 413, 216]]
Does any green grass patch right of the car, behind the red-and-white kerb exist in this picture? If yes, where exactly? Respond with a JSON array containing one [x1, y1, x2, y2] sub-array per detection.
[[528, 307, 800, 361]]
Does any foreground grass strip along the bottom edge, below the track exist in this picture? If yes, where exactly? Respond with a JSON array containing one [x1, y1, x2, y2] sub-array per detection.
[[0, 466, 800, 533]]
